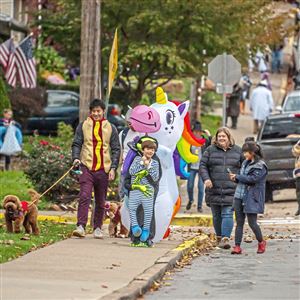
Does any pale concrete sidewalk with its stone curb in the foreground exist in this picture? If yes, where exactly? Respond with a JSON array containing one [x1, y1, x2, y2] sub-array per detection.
[[0, 229, 208, 300]]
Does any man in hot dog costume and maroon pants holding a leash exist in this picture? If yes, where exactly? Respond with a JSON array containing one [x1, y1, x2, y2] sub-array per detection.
[[72, 99, 120, 238]]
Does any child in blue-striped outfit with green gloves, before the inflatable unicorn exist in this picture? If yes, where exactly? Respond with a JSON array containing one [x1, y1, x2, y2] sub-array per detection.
[[125, 137, 161, 245]]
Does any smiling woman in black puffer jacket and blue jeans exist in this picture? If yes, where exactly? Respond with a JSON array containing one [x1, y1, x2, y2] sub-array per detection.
[[200, 127, 244, 249]]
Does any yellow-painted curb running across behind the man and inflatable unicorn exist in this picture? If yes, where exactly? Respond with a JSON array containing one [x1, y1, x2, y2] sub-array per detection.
[[0, 213, 213, 227]]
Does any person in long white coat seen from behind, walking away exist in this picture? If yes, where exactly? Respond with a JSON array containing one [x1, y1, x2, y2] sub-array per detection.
[[250, 79, 274, 134]]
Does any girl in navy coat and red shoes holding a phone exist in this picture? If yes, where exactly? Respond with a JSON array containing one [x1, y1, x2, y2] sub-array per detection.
[[229, 142, 268, 254]]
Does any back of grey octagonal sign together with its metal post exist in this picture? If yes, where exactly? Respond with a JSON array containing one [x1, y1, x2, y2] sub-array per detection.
[[208, 53, 241, 127]]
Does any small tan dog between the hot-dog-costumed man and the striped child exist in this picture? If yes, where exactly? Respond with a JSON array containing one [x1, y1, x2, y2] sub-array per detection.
[[105, 202, 129, 238]]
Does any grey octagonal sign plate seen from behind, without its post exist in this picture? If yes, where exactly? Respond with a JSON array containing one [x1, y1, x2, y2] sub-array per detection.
[[208, 54, 241, 85]]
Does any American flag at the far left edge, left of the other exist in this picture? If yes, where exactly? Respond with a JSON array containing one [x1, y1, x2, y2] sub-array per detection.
[[0, 38, 17, 87]]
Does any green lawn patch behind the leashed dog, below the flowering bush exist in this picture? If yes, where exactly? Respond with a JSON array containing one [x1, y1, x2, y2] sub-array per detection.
[[0, 171, 49, 210]]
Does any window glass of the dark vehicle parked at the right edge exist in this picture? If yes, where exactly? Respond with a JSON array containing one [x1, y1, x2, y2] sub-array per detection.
[[261, 117, 300, 140]]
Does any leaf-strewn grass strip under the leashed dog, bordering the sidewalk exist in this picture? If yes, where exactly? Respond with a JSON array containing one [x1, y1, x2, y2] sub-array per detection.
[[0, 219, 74, 263]]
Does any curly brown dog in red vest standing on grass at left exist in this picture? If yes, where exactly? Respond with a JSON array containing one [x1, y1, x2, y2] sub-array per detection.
[[3, 189, 40, 235]]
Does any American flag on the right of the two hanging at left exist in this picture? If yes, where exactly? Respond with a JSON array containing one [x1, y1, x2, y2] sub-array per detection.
[[15, 37, 36, 88]]
